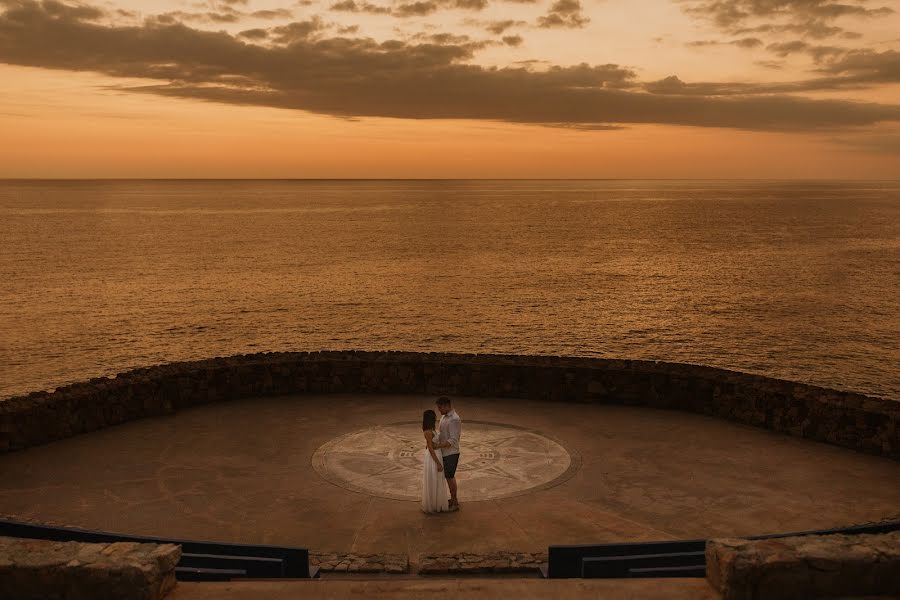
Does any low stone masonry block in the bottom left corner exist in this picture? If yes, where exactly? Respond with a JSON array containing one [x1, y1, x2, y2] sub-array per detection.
[[0, 537, 181, 600]]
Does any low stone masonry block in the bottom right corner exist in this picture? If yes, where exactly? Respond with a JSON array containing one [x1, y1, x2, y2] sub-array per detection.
[[706, 531, 900, 600]]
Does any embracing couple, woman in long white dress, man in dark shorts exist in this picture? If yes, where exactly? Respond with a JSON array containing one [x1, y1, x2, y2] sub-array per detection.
[[422, 396, 462, 513]]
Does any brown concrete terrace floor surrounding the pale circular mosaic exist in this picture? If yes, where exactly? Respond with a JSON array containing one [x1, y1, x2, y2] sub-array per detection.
[[0, 395, 900, 563]]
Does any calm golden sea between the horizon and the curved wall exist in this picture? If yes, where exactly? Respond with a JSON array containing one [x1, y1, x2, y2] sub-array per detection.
[[0, 181, 900, 399]]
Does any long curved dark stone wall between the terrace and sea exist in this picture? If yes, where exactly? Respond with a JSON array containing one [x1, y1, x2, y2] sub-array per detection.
[[0, 352, 900, 460]]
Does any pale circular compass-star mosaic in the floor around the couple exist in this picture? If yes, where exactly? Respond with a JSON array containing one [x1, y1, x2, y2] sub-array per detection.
[[312, 421, 578, 502]]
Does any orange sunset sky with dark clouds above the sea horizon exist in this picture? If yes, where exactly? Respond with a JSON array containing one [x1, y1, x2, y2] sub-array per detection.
[[0, 0, 900, 179]]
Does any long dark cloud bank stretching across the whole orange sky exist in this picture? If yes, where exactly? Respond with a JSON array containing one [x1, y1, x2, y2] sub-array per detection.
[[0, 0, 900, 131]]
